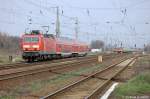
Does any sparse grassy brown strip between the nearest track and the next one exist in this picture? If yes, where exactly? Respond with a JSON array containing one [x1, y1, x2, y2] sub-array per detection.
[[1, 54, 127, 98]]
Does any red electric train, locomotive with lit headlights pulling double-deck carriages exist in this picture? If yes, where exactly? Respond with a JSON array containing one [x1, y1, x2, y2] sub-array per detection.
[[21, 30, 89, 61]]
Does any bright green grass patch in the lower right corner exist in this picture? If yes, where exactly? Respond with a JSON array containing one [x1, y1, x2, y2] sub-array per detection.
[[115, 71, 150, 96]]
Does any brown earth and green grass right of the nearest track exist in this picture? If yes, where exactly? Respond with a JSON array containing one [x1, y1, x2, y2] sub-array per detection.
[[109, 56, 150, 99]]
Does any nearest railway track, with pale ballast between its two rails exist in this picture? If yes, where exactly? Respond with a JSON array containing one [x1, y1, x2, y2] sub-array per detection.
[[41, 56, 137, 99]]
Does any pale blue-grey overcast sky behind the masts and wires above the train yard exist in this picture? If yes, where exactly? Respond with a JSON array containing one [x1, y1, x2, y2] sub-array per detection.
[[0, 0, 150, 47]]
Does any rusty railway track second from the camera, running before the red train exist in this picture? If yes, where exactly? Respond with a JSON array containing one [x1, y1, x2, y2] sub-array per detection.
[[0, 57, 97, 81]]
